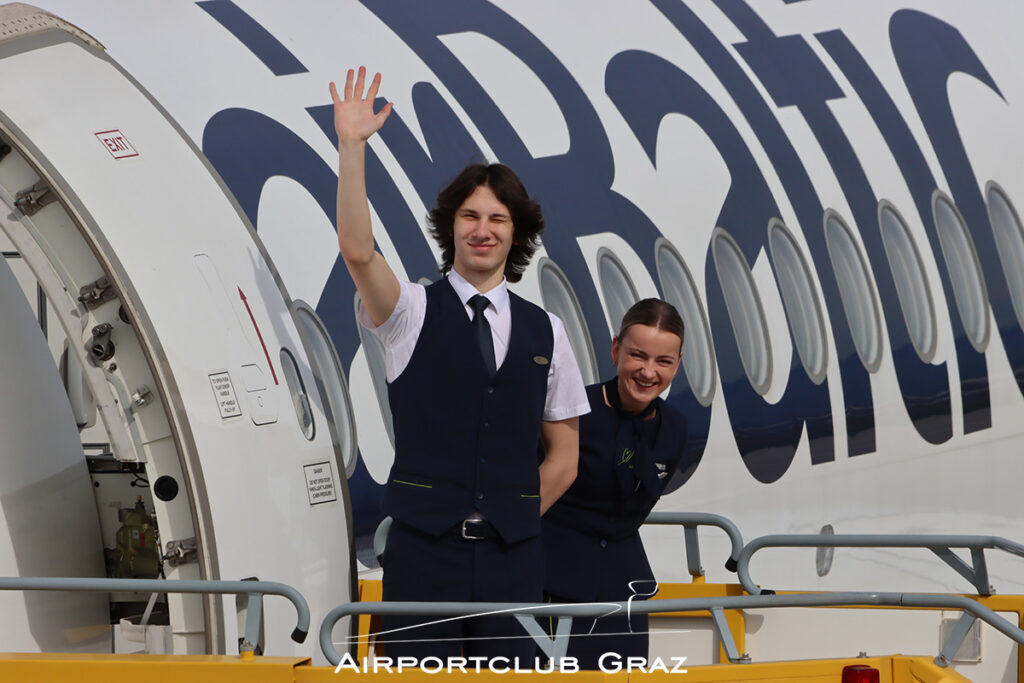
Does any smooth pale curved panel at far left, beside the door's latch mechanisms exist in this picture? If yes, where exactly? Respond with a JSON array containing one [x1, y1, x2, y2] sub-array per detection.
[[0, 241, 111, 652]]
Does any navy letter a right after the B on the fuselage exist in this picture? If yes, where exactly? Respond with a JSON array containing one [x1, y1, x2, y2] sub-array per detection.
[[605, 52, 835, 483]]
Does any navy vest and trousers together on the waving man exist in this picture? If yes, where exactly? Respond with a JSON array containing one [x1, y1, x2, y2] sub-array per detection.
[[382, 280, 554, 663]]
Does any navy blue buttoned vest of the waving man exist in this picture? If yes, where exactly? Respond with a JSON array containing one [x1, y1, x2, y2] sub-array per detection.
[[384, 280, 554, 543]]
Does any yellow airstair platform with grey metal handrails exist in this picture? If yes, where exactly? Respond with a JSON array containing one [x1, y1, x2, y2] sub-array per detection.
[[0, 513, 1024, 683]]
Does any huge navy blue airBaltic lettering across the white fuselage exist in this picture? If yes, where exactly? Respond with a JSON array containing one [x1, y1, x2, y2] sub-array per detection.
[[203, 0, 1024, 528]]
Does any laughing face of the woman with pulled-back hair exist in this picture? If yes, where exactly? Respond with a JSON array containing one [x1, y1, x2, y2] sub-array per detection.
[[611, 325, 683, 413]]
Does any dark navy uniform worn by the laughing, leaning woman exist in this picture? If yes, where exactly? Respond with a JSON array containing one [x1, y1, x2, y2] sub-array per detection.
[[543, 384, 686, 602]]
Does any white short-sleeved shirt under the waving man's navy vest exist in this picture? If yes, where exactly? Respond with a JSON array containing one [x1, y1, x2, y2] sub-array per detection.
[[359, 270, 590, 422]]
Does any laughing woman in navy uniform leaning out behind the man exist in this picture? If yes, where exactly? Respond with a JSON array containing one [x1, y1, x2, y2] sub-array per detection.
[[542, 299, 686, 669]]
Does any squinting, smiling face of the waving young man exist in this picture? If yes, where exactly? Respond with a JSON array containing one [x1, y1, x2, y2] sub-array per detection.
[[454, 185, 515, 292]]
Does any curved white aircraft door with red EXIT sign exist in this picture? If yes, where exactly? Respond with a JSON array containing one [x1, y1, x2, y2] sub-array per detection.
[[0, 8, 355, 660]]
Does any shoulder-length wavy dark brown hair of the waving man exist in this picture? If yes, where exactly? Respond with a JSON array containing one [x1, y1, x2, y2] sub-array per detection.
[[427, 164, 544, 283]]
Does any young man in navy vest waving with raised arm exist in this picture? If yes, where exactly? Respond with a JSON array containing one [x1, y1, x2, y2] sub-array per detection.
[[331, 67, 589, 664]]
